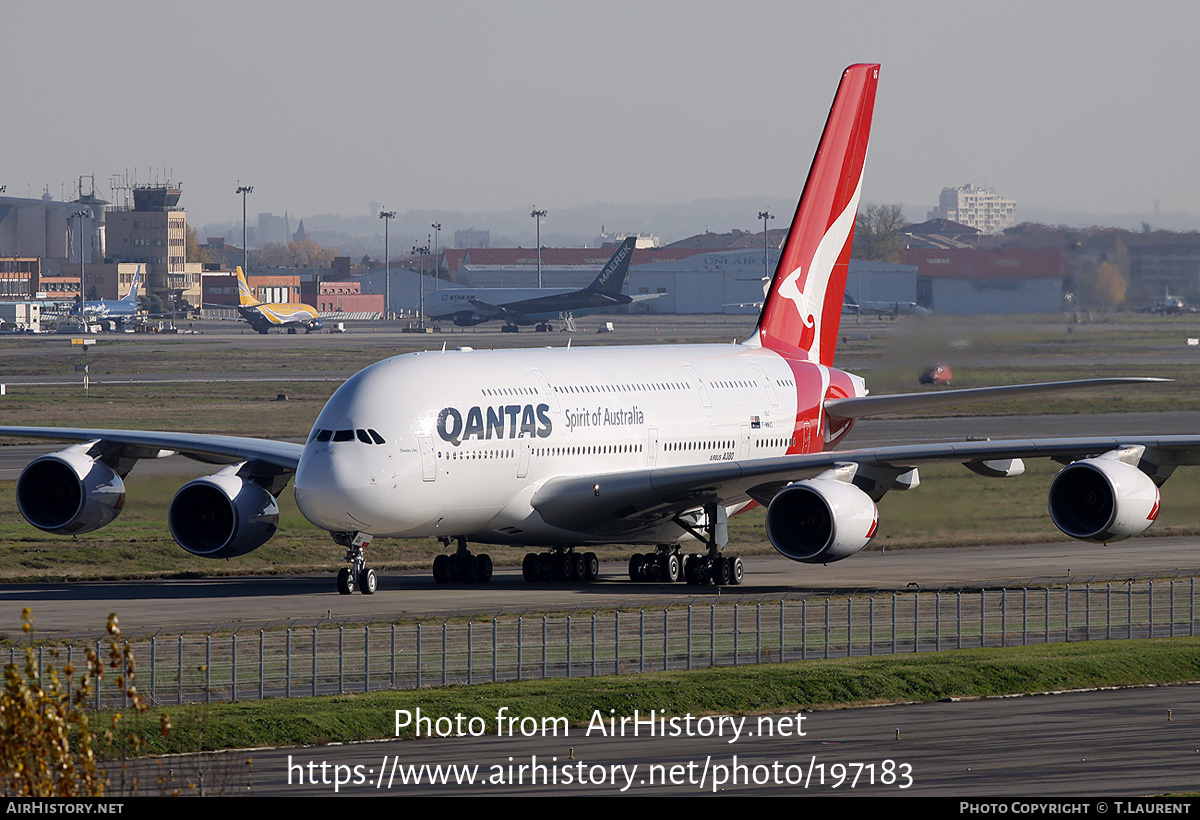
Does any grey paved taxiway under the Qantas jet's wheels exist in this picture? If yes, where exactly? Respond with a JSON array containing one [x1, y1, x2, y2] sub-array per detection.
[[0, 538, 1200, 638]]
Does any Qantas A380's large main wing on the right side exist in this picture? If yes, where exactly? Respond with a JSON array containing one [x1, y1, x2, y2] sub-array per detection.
[[532, 436, 1200, 537]]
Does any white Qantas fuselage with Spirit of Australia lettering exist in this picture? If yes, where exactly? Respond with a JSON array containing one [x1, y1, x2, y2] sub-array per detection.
[[295, 345, 862, 545]]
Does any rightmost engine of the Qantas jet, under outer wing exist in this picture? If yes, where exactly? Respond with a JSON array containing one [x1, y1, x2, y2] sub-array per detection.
[[1049, 457, 1159, 544]]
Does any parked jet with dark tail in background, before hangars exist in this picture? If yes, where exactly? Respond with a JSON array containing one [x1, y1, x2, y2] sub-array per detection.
[[422, 237, 662, 328]]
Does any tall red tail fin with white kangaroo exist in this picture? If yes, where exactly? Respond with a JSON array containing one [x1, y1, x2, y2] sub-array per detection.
[[755, 65, 880, 365]]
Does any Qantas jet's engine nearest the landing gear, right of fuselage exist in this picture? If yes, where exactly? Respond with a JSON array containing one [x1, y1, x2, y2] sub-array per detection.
[[767, 478, 880, 564]]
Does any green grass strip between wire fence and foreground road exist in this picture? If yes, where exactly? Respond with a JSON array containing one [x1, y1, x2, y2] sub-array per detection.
[[103, 638, 1200, 755]]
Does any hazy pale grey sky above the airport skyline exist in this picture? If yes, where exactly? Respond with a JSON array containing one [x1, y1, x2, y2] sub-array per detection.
[[0, 0, 1200, 223]]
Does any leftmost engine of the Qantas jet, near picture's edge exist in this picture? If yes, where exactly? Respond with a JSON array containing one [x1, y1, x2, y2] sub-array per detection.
[[17, 450, 125, 535]]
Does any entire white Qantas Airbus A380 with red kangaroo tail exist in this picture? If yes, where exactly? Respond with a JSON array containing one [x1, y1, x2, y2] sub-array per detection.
[[0, 65, 1200, 593]]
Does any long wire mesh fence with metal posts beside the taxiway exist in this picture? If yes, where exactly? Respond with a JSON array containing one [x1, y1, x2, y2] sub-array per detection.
[[10, 577, 1196, 706]]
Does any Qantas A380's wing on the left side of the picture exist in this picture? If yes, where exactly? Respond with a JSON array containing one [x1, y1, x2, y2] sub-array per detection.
[[0, 427, 304, 472]]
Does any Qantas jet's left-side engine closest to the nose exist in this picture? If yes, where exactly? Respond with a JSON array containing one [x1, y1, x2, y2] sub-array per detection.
[[167, 473, 280, 558]]
